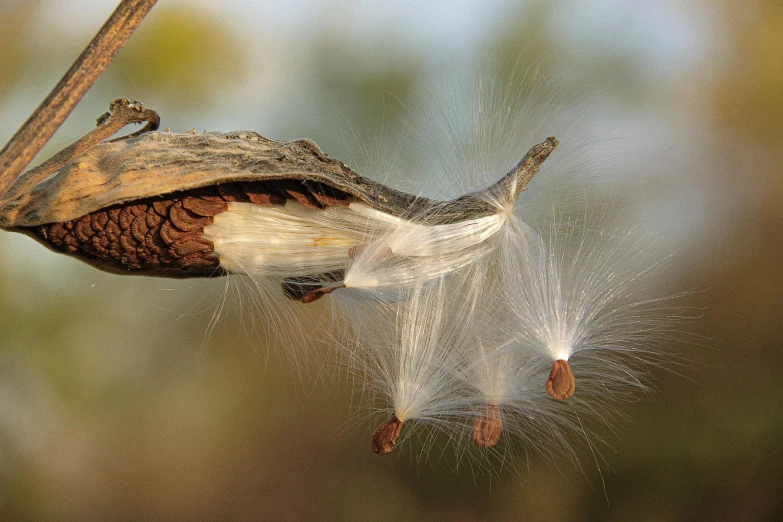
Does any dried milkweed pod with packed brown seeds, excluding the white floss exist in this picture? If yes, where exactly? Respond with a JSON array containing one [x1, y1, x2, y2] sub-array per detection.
[[0, 99, 558, 276]]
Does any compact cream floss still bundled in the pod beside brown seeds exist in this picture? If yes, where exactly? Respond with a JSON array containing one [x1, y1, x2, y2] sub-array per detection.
[[204, 200, 505, 288]]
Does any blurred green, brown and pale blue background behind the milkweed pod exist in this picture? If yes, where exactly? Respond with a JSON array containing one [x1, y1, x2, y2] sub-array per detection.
[[0, 0, 783, 520]]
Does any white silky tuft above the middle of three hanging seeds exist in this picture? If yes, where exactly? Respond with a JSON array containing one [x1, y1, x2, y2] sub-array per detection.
[[444, 260, 592, 464]]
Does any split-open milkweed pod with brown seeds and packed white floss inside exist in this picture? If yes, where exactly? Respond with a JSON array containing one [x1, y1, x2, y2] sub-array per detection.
[[0, 99, 558, 302]]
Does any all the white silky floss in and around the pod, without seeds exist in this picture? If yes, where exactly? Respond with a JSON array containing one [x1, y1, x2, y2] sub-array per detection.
[[205, 54, 679, 462]]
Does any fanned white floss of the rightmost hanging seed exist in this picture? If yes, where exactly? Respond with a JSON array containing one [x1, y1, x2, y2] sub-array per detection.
[[498, 206, 685, 404]]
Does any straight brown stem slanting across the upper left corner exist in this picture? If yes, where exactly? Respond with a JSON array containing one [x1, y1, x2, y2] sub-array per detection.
[[0, 0, 157, 196]]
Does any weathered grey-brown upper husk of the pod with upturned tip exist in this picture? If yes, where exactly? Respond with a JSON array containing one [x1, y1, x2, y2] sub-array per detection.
[[0, 111, 558, 229]]
